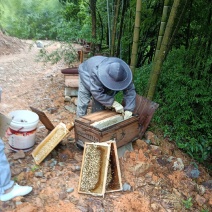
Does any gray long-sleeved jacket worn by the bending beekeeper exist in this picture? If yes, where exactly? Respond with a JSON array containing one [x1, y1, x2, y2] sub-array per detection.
[[78, 56, 136, 111]]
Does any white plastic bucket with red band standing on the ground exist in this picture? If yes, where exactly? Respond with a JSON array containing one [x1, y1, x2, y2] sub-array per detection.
[[7, 110, 39, 152]]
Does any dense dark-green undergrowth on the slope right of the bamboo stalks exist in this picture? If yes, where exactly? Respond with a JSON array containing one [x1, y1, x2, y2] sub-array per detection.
[[152, 48, 212, 162]]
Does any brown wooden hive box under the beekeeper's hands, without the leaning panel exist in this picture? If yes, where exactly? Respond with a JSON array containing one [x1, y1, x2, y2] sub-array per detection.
[[75, 111, 140, 147]]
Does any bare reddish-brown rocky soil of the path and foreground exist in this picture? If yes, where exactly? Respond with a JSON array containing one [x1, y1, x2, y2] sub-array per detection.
[[0, 33, 212, 212]]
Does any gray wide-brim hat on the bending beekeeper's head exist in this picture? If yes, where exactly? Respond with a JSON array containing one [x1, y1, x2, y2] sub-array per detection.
[[97, 57, 132, 91]]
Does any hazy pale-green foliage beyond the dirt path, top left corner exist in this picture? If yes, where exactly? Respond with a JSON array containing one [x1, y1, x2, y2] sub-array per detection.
[[2, 0, 61, 39]]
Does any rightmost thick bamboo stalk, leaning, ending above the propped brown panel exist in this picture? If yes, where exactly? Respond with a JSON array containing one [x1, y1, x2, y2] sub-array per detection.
[[147, 0, 181, 100]]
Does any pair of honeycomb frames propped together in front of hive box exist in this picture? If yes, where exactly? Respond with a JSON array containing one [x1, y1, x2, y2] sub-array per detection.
[[78, 141, 122, 197]]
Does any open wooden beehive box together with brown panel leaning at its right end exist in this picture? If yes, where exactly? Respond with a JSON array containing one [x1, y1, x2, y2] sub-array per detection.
[[75, 95, 159, 147]]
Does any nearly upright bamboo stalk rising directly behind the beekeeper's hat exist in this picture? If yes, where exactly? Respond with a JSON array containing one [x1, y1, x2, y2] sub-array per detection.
[[130, 0, 142, 73]]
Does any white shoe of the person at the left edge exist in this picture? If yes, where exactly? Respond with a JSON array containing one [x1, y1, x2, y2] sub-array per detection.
[[0, 184, 32, 202]]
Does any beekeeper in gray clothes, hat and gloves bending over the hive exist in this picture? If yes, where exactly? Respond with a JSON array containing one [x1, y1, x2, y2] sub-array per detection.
[[77, 56, 136, 119]]
